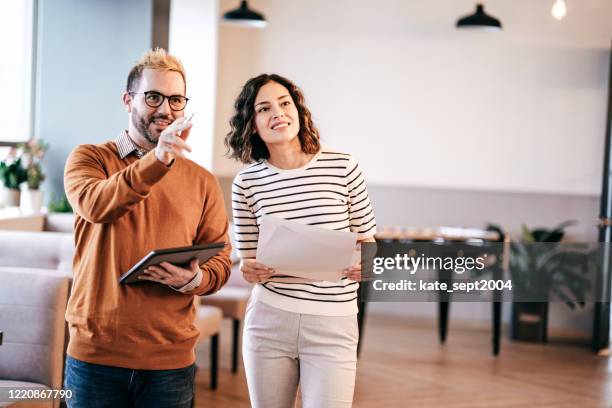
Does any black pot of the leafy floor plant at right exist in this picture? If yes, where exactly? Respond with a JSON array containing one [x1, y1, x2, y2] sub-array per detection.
[[511, 302, 548, 343]]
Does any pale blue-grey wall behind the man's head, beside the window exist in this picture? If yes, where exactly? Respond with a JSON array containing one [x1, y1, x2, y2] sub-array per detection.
[[34, 0, 152, 198]]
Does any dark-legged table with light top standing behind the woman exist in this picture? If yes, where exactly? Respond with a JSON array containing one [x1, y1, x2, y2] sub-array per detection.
[[366, 227, 509, 355]]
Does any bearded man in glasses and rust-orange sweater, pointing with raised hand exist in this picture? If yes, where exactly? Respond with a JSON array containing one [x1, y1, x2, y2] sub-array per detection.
[[64, 49, 230, 408]]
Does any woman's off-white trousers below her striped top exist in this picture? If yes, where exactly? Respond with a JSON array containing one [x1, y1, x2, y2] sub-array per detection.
[[242, 299, 359, 408]]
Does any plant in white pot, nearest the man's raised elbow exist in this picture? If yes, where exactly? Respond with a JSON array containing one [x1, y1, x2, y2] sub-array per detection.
[[19, 139, 49, 214]]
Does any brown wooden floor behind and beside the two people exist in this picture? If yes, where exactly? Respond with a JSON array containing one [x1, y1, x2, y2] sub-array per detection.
[[196, 315, 612, 408]]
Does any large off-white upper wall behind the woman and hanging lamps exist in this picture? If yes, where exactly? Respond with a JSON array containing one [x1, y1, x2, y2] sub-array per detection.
[[212, 0, 612, 195]]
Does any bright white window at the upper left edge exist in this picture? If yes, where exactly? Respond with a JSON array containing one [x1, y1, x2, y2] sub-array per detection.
[[0, 0, 36, 154]]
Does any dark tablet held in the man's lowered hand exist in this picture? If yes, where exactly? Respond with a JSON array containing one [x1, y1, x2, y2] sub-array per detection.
[[119, 242, 226, 283]]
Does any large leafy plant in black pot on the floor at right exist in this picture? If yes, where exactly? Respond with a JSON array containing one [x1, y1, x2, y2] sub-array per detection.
[[490, 221, 596, 343]]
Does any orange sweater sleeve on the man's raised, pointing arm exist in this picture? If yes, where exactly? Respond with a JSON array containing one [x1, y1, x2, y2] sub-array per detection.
[[64, 145, 170, 223]]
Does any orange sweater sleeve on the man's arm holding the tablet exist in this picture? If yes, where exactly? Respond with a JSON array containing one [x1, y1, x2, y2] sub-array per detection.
[[183, 174, 232, 296]]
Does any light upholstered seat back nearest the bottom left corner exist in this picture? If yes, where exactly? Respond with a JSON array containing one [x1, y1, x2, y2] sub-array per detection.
[[0, 231, 74, 407]]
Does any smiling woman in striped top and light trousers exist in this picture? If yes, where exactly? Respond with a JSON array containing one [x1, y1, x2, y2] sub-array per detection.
[[225, 74, 376, 408]]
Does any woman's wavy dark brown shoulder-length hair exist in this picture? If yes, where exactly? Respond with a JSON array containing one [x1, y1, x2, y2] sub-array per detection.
[[225, 74, 321, 163]]
